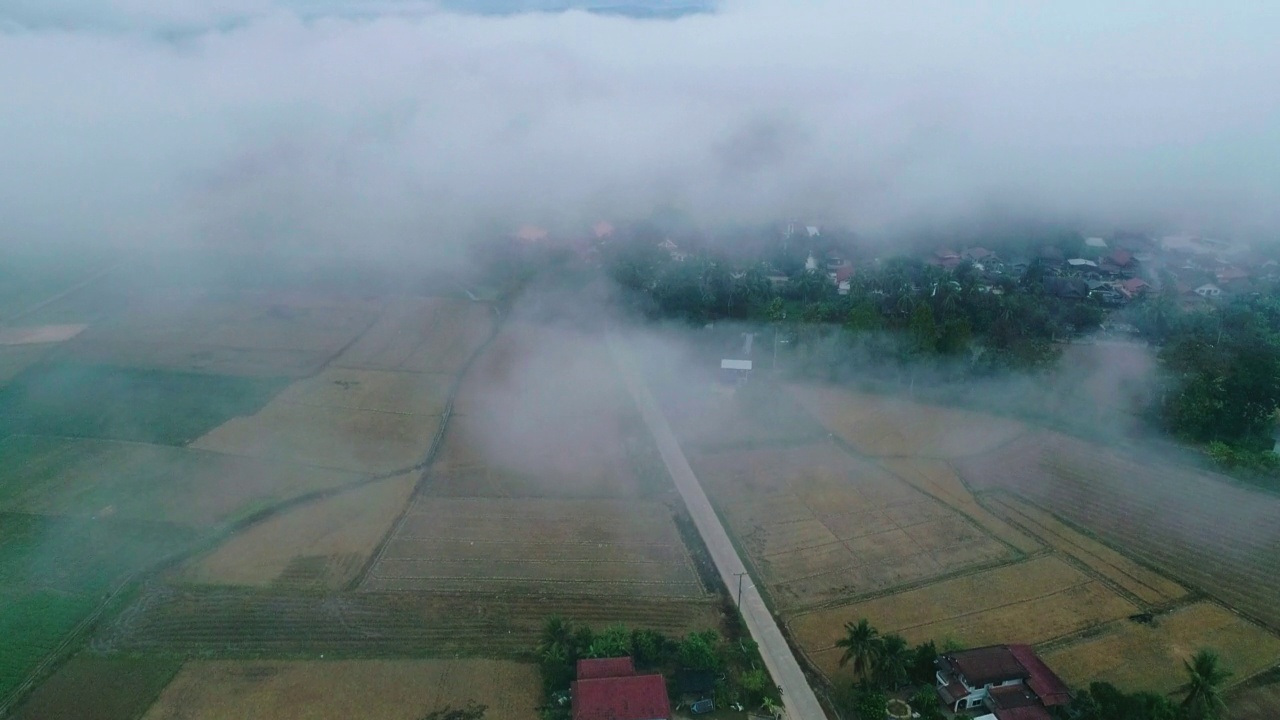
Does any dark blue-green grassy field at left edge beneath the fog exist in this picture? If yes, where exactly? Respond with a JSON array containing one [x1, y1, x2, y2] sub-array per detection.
[[0, 364, 288, 445]]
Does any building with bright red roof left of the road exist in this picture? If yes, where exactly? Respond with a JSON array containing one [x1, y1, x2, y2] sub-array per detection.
[[570, 657, 671, 720]]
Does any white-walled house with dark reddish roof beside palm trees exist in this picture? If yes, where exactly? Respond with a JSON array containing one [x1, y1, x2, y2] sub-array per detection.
[[936, 644, 1071, 720]]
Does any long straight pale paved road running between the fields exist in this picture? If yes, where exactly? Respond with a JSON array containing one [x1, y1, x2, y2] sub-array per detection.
[[608, 333, 827, 720]]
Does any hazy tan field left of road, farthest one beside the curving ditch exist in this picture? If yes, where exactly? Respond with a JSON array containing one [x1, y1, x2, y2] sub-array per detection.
[[334, 297, 494, 375]]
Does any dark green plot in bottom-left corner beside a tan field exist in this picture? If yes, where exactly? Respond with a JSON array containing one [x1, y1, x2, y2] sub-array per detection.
[[13, 655, 179, 720]]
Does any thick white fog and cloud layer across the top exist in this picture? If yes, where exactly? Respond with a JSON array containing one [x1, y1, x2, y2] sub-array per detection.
[[0, 0, 1280, 258]]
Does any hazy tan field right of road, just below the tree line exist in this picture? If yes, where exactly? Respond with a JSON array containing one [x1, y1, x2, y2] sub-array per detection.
[[787, 384, 1027, 459]]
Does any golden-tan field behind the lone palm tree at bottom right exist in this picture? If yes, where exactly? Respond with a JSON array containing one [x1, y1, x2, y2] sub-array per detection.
[[1044, 602, 1280, 693]]
